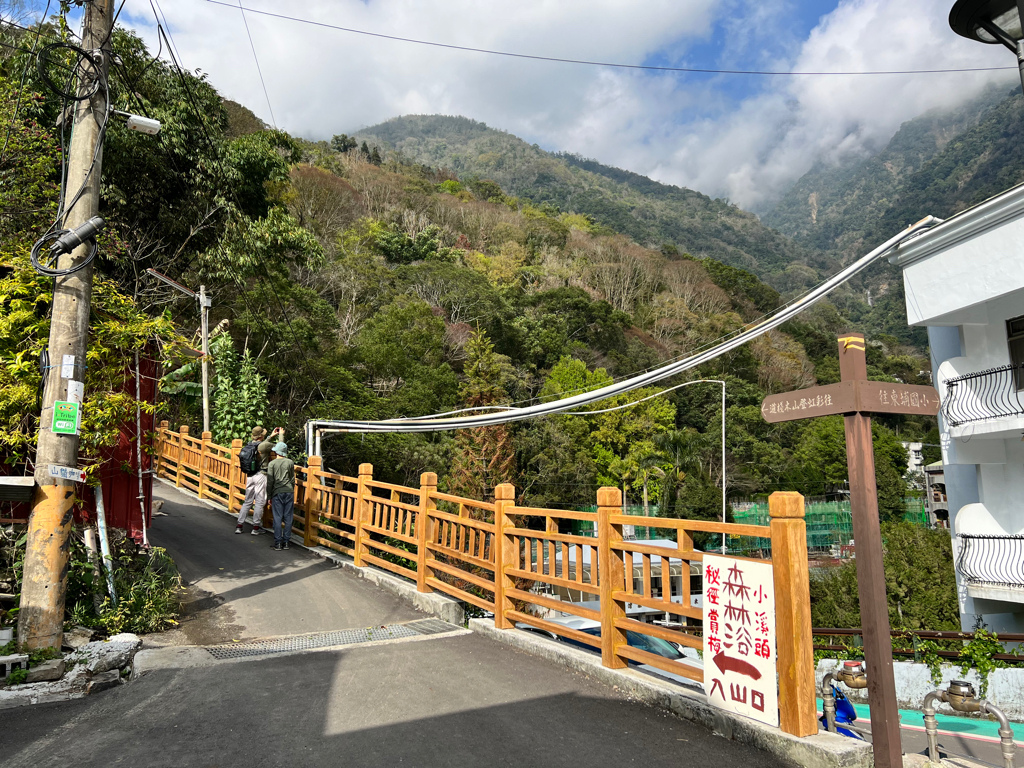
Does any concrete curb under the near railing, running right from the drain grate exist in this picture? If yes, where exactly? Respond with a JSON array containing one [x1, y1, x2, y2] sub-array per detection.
[[469, 618, 874, 768]]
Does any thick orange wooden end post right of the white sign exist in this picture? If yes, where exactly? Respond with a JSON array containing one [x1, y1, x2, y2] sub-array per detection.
[[768, 490, 818, 736]]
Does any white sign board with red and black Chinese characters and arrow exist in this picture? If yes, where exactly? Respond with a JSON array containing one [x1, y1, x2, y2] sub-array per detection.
[[703, 554, 778, 727]]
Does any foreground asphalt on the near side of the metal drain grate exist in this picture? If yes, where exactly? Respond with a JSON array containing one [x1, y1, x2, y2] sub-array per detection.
[[0, 635, 780, 768]]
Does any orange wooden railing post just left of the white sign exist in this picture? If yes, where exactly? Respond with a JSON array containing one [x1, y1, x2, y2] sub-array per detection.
[[597, 487, 633, 670]]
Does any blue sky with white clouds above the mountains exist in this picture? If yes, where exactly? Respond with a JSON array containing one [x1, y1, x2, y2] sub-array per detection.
[[14, 0, 1016, 210]]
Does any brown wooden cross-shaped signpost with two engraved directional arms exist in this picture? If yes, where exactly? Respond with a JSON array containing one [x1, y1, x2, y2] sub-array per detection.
[[761, 334, 939, 768]]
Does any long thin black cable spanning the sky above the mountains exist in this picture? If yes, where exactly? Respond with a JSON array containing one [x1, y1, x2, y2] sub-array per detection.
[[206, 0, 1017, 77]]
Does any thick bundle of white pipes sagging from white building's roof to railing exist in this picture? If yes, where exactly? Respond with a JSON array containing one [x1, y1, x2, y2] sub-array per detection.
[[306, 216, 941, 439]]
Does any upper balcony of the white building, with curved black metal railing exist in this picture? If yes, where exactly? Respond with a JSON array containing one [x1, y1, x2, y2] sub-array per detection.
[[940, 364, 1024, 437]]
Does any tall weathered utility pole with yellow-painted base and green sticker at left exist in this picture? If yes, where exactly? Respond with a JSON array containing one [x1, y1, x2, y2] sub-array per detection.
[[17, 0, 114, 648]]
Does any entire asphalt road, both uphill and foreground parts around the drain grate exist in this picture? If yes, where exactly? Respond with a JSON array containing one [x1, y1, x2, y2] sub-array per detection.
[[0, 488, 783, 768]]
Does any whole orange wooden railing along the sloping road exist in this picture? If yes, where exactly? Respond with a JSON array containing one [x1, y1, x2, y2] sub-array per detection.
[[157, 422, 817, 736]]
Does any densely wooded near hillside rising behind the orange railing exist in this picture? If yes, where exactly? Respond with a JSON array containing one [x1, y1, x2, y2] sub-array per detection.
[[0, 19, 932, 518]]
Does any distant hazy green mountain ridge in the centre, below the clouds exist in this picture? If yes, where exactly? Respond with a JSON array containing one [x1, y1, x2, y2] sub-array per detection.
[[357, 115, 827, 284]]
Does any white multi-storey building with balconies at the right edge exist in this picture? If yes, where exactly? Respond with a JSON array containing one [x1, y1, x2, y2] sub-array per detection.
[[890, 185, 1024, 632]]
